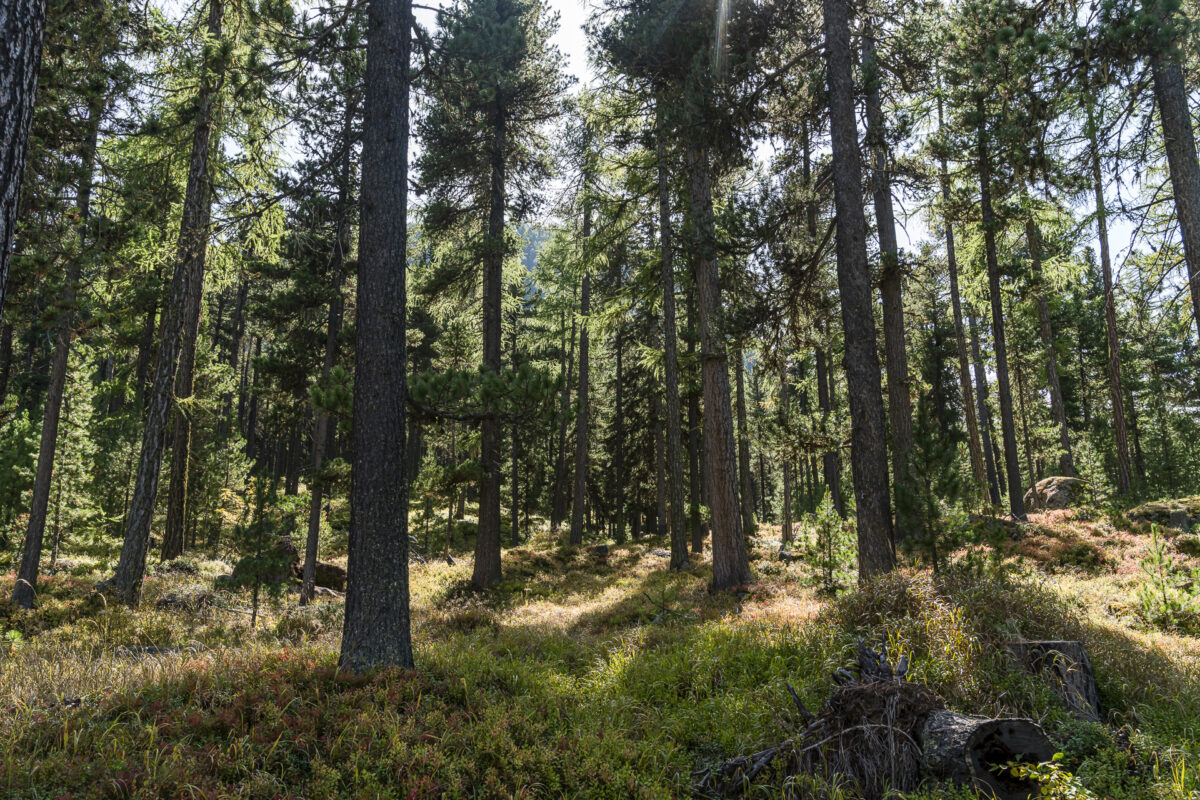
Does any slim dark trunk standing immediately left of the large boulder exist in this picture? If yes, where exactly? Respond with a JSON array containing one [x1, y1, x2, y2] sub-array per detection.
[[978, 100, 1025, 521]]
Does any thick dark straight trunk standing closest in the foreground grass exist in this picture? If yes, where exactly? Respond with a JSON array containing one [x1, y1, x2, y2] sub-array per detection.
[[338, 0, 413, 672]]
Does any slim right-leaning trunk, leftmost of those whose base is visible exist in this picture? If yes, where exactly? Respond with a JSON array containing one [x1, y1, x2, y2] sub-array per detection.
[[13, 97, 107, 608]]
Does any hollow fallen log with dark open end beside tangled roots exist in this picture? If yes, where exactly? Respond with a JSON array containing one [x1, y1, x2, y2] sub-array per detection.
[[920, 709, 1055, 800]]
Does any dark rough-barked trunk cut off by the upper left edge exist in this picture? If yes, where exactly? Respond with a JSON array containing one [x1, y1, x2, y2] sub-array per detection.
[[0, 0, 46, 326]]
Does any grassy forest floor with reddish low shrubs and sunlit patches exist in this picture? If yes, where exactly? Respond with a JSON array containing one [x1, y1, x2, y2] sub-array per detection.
[[0, 511, 1200, 800]]
